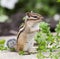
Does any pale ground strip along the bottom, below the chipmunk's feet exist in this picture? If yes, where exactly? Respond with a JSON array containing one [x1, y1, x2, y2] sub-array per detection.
[[0, 51, 37, 59]]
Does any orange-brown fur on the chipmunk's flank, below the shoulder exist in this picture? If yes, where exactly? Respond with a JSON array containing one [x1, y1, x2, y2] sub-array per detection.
[[16, 27, 29, 51]]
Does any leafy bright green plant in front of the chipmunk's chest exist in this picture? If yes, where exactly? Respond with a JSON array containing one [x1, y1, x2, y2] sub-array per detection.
[[35, 22, 60, 59]]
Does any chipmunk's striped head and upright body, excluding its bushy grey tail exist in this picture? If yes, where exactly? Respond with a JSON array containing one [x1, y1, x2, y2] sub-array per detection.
[[7, 12, 43, 52]]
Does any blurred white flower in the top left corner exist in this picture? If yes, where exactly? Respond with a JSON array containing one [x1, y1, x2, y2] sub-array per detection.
[[1, 0, 18, 9]]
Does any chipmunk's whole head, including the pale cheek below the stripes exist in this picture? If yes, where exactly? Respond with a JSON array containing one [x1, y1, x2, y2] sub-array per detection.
[[26, 11, 44, 25]]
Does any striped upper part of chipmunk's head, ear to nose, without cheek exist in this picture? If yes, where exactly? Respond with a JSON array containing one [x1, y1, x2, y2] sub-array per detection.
[[26, 11, 44, 21]]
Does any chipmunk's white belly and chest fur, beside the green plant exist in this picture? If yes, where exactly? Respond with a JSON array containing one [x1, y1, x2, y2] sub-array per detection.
[[24, 22, 39, 51]]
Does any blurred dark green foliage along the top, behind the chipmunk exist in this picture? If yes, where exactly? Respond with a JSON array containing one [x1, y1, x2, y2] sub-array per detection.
[[0, 0, 60, 17]]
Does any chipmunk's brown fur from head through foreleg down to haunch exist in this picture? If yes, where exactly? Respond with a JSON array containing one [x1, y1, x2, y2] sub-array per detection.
[[16, 12, 43, 51]]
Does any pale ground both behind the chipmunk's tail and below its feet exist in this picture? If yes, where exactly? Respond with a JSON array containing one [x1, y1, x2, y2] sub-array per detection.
[[0, 36, 37, 59]]
